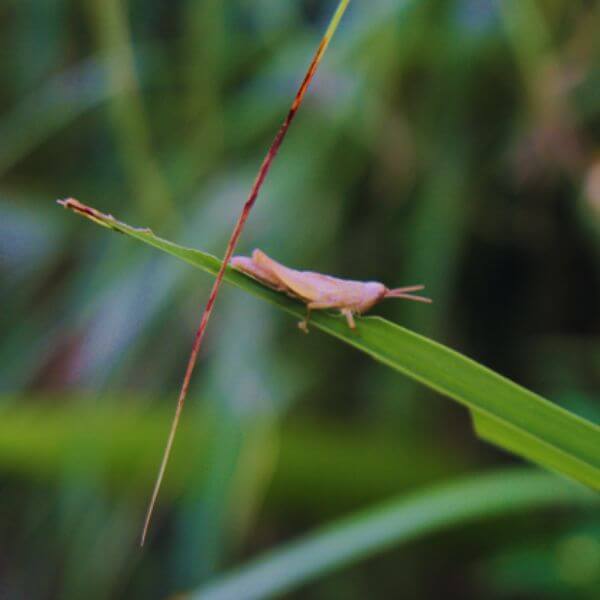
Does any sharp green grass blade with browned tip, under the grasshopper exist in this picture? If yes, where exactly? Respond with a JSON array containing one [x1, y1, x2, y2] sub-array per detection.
[[60, 199, 600, 489]]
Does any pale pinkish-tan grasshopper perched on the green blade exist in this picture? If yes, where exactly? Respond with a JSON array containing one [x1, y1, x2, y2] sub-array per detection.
[[230, 249, 431, 333]]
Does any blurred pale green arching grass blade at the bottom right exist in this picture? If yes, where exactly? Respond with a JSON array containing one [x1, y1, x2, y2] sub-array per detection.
[[191, 469, 598, 600]]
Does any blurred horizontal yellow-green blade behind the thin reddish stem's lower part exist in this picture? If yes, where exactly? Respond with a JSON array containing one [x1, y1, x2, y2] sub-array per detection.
[[0, 393, 478, 506]]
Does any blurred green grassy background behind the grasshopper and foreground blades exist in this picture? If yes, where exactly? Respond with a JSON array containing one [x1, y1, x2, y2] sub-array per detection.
[[0, 0, 600, 600]]
